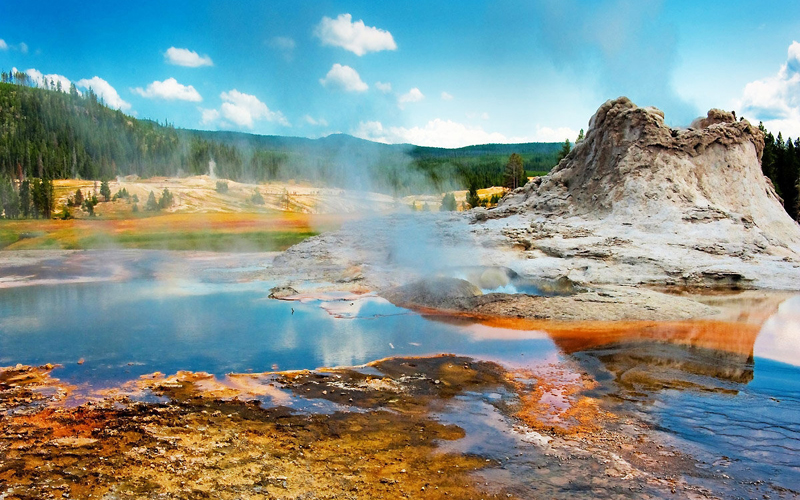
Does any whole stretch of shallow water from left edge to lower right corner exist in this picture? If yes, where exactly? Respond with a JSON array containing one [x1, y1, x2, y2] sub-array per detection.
[[0, 276, 800, 497]]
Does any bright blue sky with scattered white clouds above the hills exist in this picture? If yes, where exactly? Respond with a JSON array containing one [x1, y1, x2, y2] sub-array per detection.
[[0, 0, 800, 147]]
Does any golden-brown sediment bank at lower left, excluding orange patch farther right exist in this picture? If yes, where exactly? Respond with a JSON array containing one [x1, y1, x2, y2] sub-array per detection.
[[0, 356, 520, 499]]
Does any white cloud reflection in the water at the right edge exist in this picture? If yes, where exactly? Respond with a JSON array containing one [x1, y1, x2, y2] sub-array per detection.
[[755, 295, 800, 366]]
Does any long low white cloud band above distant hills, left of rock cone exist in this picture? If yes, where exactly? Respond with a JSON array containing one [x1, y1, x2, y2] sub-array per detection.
[[351, 118, 578, 148]]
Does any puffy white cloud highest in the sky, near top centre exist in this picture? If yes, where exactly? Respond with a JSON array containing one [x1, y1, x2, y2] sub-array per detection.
[[314, 14, 397, 56]]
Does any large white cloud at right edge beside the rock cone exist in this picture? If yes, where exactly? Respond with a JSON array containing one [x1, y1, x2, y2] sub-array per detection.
[[737, 41, 800, 137]]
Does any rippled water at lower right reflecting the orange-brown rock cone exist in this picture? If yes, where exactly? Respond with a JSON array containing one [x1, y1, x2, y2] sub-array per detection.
[[553, 297, 800, 498]]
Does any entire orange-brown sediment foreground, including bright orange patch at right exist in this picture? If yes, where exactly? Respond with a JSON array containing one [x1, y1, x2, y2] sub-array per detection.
[[0, 355, 736, 500]]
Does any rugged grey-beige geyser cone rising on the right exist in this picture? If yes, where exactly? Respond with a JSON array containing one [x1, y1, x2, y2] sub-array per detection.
[[500, 97, 800, 251]]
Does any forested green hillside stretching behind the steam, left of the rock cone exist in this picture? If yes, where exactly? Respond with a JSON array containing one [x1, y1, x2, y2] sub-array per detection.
[[0, 80, 560, 195]]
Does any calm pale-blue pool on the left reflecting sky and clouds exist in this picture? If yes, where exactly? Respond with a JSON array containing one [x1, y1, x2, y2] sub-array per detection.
[[0, 280, 558, 387]]
